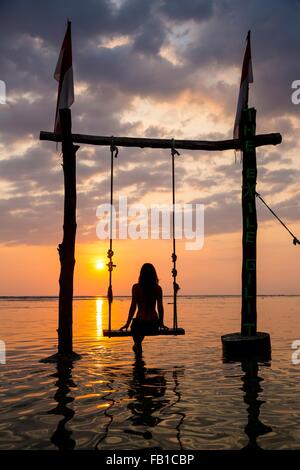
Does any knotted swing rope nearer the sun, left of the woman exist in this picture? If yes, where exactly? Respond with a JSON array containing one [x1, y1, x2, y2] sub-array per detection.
[[106, 137, 119, 332]]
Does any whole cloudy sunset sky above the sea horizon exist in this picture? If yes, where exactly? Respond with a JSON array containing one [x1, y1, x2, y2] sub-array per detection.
[[0, 0, 300, 295]]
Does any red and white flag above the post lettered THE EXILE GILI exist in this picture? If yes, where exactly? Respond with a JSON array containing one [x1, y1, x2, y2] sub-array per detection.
[[233, 31, 253, 139]]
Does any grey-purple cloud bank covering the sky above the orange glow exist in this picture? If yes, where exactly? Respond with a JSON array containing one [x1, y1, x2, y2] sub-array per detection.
[[0, 0, 300, 248]]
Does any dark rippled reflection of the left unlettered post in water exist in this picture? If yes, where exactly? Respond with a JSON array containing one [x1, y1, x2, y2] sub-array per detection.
[[48, 360, 76, 450]]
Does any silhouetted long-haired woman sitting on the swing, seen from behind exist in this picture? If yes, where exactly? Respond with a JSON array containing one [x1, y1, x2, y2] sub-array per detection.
[[121, 263, 167, 354]]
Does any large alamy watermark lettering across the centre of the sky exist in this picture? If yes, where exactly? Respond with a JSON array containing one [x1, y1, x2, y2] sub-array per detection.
[[96, 196, 204, 250]]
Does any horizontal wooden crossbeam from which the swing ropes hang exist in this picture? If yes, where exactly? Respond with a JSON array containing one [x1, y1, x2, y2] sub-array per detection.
[[40, 131, 282, 151]]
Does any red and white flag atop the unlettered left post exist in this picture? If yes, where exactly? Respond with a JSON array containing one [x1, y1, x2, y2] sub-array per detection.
[[54, 21, 74, 134]]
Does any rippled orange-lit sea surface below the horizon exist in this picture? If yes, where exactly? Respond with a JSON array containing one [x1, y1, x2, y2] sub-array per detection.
[[0, 297, 300, 450]]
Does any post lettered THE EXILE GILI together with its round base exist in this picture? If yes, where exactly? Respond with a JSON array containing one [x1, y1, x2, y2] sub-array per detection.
[[222, 108, 271, 361]]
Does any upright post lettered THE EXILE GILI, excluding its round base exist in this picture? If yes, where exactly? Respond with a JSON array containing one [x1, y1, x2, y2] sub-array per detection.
[[241, 108, 257, 336]]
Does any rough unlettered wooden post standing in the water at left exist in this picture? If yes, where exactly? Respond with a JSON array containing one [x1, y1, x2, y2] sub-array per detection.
[[58, 109, 79, 355]]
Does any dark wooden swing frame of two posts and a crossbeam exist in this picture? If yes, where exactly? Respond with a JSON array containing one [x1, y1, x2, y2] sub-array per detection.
[[40, 108, 282, 355]]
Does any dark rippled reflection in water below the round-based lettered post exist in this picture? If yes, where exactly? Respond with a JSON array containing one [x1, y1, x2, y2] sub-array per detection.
[[241, 358, 272, 450]]
